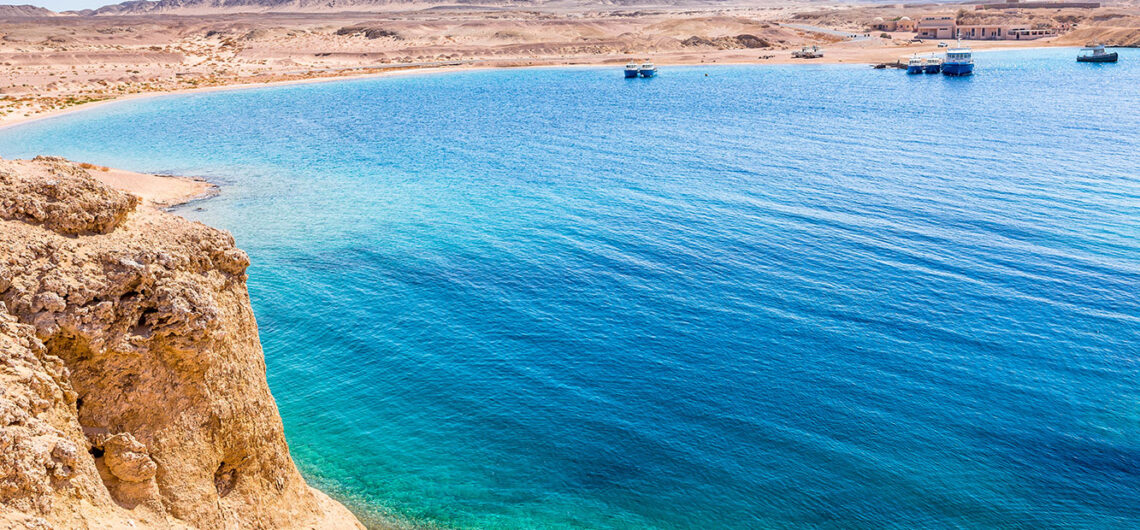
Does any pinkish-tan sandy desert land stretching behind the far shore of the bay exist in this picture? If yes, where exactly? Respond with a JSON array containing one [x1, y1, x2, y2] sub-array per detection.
[[0, 2, 1140, 124]]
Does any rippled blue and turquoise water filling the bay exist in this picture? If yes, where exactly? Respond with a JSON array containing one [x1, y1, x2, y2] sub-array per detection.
[[0, 50, 1140, 528]]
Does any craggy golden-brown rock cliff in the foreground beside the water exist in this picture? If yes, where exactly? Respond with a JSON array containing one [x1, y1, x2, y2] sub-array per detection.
[[0, 158, 360, 529]]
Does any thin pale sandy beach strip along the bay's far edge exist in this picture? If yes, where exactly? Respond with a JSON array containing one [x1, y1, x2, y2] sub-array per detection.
[[0, 41, 1076, 130]]
